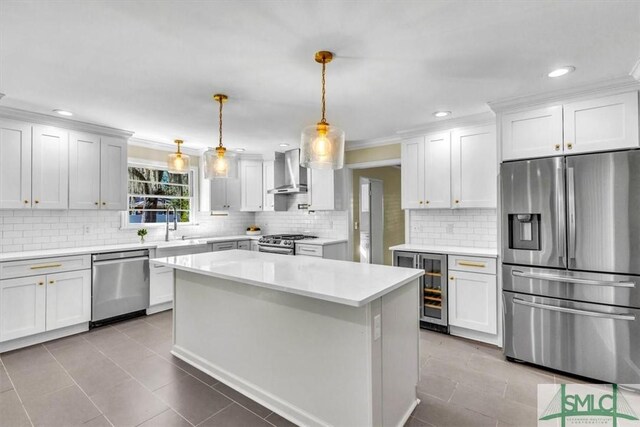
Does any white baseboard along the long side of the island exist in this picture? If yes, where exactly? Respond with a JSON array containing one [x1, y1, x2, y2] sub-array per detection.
[[171, 345, 330, 426]]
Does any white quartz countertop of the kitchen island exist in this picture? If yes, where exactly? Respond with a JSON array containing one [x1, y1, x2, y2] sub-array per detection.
[[151, 250, 424, 307]]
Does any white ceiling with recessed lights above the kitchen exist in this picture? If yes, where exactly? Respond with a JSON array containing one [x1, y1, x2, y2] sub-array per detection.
[[0, 0, 640, 152]]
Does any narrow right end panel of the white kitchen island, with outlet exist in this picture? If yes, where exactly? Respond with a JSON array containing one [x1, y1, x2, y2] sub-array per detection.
[[382, 279, 420, 426]]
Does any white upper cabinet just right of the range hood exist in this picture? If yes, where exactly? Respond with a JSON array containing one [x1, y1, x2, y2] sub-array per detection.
[[307, 169, 344, 211]]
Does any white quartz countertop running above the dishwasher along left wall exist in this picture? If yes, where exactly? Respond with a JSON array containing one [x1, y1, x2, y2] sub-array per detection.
[[0, 235, 261, 262]]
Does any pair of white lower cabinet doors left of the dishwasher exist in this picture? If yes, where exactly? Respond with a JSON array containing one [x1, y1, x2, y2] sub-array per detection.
[[0, 270, 91, 342]]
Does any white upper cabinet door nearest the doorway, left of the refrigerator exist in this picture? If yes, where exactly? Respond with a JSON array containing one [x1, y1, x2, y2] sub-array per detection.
[[400, 137, 424, 209]]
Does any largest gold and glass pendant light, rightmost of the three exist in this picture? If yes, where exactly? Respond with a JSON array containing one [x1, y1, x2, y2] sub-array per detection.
[[300, 51, 344, 169]]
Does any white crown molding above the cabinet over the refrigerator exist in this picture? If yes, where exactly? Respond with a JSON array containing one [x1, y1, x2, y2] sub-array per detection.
[[487, 75, 640, 113]]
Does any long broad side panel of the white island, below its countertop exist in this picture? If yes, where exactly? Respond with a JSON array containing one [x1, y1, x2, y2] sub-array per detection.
[[173, 271, 379, 426]]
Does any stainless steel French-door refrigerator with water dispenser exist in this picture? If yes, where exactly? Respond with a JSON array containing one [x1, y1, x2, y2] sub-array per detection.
[[501, 151, 640, 384]]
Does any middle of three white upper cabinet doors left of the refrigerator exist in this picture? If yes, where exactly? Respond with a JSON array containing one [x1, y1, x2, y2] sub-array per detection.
[[423, 132, 451, 209]]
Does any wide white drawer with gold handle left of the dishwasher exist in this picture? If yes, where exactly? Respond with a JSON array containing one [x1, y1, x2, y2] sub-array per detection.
[[0, 255, 91, 279]]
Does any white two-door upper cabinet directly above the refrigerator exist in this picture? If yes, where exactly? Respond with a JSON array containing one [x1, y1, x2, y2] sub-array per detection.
[[501, 91, 640, 160]]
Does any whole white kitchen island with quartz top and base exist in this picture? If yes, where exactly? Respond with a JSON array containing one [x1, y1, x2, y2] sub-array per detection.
[[152, 250, 423, 427]]
